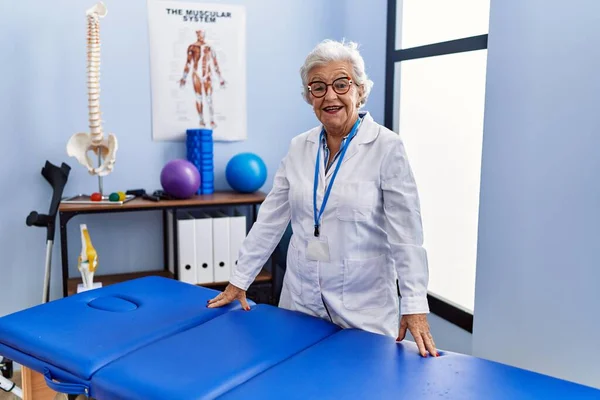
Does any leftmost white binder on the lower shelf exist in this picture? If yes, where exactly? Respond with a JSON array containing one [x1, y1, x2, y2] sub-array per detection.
[[177, 212, 197, 284]]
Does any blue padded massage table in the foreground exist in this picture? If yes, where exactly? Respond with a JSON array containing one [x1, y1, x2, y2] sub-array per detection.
[[0, 277, 600, 400]]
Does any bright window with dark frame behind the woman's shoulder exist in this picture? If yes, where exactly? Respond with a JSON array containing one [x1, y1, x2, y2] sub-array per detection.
[[385, 0, 489, 331]]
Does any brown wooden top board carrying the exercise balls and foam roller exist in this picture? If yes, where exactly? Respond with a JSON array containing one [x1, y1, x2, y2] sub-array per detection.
[[58, 191, 266, 213]]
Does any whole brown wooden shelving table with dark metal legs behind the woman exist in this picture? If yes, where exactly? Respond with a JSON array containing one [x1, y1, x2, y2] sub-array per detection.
[[58, 192, 275, 300]]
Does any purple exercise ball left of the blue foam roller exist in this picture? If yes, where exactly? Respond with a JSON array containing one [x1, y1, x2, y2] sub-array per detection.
[[160, 159, 200, 199]]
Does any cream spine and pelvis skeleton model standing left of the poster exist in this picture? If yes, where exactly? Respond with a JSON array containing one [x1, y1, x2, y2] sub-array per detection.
[[67, 2, 118, 176]]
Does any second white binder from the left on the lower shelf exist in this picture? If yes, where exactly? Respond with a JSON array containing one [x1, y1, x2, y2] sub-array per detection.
[[190, 212, 215, 284]]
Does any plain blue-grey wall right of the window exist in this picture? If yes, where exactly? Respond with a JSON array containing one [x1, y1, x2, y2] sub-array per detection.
[[473, 0, 600, 388]]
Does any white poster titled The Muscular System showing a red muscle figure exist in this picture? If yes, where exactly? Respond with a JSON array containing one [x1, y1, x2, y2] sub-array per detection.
[[148, 0, 246, 141]]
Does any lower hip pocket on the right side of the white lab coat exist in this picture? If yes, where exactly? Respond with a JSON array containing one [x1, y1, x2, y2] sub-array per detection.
[[342, 254, 388, 310]]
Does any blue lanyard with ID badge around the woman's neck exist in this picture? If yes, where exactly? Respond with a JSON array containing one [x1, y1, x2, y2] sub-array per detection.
[[306, 118, 360, 261]]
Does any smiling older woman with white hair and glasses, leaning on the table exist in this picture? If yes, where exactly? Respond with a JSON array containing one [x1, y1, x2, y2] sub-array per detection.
[[208, 40, 438, 357]]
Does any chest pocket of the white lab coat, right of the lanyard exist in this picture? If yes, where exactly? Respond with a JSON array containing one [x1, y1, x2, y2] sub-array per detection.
[[334, 181, 377, 221]]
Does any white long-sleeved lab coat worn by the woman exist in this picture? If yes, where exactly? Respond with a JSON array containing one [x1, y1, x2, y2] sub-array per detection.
[[230, 113, 429, 337]]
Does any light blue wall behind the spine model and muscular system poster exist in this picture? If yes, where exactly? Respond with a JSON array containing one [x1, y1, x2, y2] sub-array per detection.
[[0, 0, 342, 316]]
